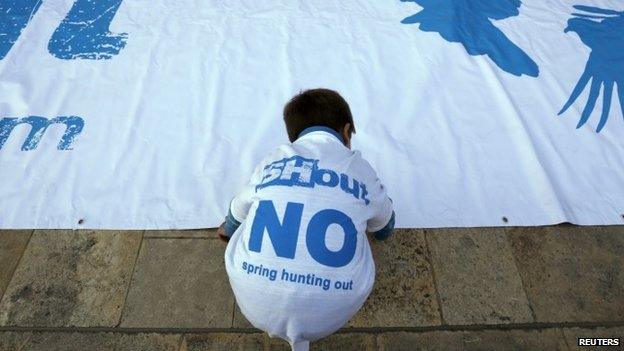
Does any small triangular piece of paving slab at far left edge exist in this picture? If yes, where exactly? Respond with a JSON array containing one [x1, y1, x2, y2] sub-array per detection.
[[0, 230, 32, 298]]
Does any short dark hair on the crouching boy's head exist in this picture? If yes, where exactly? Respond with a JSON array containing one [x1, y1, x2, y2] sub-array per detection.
[[284, 89, 355, 142]]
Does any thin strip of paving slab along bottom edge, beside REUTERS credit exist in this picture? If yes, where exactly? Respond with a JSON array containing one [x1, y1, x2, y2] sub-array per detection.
[[377, 329, 568, 351]]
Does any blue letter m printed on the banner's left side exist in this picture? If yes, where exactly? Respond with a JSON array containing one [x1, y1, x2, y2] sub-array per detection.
[[0, 116, 84, 151]]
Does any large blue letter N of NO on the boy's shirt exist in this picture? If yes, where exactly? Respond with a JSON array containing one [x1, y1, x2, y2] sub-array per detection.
[[249, 200, 303, 258]]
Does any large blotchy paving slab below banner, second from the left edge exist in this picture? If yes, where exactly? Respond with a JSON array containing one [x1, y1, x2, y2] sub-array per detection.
[[0, 230, 142, 327]]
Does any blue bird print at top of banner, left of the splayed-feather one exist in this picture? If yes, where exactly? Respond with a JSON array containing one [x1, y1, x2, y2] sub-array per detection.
[[401, 0, 539, 77]]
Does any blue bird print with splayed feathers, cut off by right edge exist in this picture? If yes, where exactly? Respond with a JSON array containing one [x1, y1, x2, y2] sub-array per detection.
[[559, 5, 624, 132]]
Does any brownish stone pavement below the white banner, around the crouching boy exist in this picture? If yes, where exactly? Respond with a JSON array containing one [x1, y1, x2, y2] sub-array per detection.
[[0, 225, 624, 351]]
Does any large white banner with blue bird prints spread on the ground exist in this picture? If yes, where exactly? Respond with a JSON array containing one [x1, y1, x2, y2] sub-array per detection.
[[0, 0, 624, 229]]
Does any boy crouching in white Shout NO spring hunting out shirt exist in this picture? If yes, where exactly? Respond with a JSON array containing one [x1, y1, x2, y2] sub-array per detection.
[[218, 89, 394, 351]]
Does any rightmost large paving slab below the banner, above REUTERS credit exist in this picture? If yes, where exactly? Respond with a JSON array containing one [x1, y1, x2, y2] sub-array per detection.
[[507, 225, 624, 322]]
